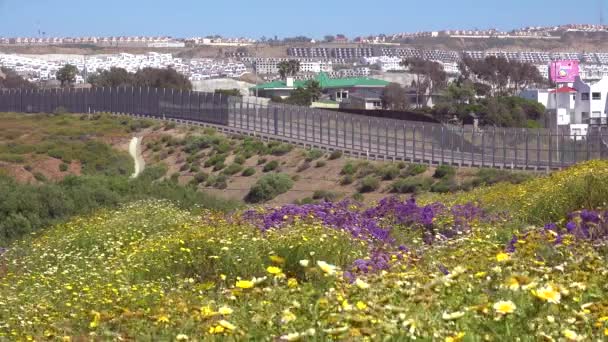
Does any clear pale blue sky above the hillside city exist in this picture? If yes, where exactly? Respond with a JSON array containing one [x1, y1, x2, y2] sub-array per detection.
[[0, 0, 608, 38]]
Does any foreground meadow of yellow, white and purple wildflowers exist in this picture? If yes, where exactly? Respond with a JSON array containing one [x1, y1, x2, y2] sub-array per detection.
[[0, 161, 608, 341]]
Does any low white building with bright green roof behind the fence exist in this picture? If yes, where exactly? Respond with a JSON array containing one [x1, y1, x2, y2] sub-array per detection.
[[249, 72, 389, 102]]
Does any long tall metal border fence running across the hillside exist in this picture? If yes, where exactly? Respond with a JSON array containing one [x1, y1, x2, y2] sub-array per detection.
[[0, 88, 608, 170]]
